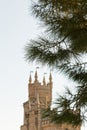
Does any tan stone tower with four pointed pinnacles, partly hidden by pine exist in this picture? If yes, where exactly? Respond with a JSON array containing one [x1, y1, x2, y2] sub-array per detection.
[[20, 71, 80, 130]]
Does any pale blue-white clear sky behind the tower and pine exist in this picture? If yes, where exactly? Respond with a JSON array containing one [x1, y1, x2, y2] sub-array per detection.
[[0, 0, 86, 130]]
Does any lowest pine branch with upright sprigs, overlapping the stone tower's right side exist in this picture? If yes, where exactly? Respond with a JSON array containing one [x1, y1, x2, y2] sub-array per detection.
[[42, 86, 87, 127]]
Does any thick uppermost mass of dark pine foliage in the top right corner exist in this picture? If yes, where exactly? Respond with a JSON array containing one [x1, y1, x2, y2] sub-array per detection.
[[32, 0, 87, 52]]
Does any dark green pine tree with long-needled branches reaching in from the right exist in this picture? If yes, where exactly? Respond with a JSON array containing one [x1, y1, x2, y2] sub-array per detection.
[[25, 0, 87, 125]]
